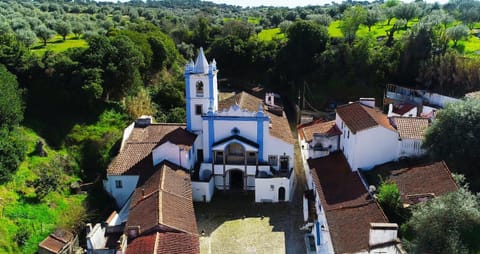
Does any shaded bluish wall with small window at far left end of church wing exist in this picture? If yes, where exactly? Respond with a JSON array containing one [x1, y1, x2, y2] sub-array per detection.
[[103, 175, 139, 208]]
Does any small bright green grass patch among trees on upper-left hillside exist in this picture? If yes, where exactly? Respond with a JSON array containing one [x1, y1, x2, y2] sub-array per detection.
[[32, 35, 88, 55]]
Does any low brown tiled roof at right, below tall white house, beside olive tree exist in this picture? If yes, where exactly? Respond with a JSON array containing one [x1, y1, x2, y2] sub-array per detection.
[[389, 161, 458, 204]]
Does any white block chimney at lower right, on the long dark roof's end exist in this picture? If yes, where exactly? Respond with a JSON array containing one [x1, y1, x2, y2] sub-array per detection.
[[368, 223, 398, 248]]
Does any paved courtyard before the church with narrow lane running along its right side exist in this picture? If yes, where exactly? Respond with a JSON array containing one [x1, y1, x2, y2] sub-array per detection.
[[195, 140, 306, 254]]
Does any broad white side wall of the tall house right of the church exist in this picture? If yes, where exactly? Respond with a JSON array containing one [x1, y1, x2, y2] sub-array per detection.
[[350, 126, 398, 171]]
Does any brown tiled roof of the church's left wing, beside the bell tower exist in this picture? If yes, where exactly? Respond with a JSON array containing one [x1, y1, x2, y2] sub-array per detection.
[[107, 123, 196, 175]]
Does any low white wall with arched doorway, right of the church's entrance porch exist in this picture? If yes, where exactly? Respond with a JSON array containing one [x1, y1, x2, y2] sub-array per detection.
[[255, 177, 293, 203]]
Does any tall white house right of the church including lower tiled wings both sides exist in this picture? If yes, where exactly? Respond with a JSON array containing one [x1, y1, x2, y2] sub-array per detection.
[[299, 98, 430, 171]]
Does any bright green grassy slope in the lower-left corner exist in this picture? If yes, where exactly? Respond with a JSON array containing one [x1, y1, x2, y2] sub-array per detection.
[[0, 128, 86, 253]]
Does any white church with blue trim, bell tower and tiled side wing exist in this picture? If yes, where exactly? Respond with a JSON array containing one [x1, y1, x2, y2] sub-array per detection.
[[104, 49, 295, 207]]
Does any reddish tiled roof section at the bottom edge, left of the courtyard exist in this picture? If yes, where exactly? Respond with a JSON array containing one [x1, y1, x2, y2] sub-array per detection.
[[127, 232, 200, 254]]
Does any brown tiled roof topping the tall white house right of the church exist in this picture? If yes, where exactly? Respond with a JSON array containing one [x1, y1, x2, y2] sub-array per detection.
[[336, 102, 395, 133]]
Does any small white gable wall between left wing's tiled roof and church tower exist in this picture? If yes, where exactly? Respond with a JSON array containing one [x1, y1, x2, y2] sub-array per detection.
[[152, 142, 195, 169]]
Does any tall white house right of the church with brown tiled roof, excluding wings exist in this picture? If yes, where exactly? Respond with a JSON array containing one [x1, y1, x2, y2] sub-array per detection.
[[335, 100, 398, 171]]
